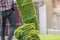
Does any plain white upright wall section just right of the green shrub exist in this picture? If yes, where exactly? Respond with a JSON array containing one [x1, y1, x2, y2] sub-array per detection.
[[39, 5, 47, 34]]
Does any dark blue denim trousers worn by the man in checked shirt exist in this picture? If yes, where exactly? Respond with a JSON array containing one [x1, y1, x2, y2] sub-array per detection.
[[1, 9, 16, 40]]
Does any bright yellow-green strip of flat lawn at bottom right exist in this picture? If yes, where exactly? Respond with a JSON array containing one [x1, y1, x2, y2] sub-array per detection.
[[40, 34, 60, 40]]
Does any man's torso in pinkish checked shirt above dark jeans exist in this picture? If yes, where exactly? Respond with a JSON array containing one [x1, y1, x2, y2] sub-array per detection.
[[0, 0, 13, 11]]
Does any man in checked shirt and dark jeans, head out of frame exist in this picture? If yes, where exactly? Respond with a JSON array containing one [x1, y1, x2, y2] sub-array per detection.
[[0, 0, 16, 40]]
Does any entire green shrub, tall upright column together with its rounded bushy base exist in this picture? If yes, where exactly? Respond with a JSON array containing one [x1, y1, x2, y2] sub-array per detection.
[[14, 0, 40, 40]]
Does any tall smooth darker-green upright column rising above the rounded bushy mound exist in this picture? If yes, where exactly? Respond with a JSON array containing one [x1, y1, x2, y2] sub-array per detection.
[[16, 0, 39, 29]]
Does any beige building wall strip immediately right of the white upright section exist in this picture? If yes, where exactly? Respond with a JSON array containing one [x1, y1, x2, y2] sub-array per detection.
[[44, 0, 53, 28]]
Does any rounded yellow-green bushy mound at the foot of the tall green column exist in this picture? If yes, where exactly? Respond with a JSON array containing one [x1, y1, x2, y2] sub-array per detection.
[[14, 23, 40, 40]]
